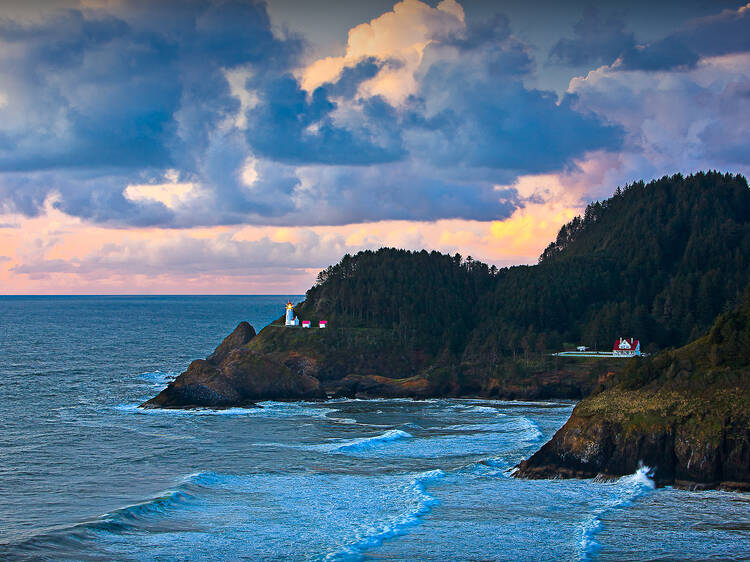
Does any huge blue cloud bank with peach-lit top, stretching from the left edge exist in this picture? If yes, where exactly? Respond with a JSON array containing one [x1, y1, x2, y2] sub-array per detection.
[[0, 0, 636, 228]]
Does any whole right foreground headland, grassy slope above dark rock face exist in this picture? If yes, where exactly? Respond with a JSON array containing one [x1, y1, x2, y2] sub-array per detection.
[[517, 293, 750, 490]]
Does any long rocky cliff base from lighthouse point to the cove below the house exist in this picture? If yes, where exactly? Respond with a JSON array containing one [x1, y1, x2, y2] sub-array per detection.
[[143, 310, 622, 408]]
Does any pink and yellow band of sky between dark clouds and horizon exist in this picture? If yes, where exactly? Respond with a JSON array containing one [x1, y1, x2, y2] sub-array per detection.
[[0, 194, 578, 294]]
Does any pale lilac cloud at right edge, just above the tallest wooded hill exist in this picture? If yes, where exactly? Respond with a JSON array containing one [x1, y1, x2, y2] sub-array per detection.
[[570, 54, 750, 177]]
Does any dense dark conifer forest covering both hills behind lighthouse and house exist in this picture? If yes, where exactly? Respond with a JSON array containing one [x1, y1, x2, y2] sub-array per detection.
[[298, 168, 750, 363]]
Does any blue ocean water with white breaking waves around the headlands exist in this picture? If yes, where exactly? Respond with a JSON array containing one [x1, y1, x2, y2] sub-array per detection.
[[0, 296, 750, 560]]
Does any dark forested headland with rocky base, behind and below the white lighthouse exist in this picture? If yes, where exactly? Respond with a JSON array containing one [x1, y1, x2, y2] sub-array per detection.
[[144, 167, 750, 405]]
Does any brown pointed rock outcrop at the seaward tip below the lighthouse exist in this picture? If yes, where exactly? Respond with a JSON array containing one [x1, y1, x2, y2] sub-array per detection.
[[142, 322, 325, 408]]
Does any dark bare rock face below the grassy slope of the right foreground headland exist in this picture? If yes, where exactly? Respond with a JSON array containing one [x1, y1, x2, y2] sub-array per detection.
[[517, 394, 750, 491]]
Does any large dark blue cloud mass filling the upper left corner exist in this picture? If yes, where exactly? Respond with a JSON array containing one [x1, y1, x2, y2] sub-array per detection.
[[0, 1, 302, 225]]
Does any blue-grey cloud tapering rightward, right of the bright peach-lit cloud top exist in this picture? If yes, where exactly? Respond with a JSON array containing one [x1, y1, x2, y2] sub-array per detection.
[[405, 18, 622, 173]]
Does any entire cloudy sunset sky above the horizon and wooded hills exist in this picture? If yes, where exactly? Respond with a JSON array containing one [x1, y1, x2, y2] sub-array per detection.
[[0, 0, 750, 294]]
